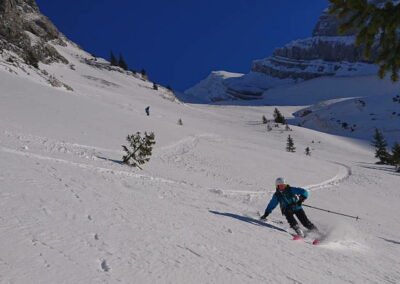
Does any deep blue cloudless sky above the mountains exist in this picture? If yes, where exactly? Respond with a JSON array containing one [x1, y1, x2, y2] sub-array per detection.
[[37, 0, 328, 91]]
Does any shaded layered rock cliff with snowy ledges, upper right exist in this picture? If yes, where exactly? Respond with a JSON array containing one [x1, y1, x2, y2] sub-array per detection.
[[251, 8, 371, 80]]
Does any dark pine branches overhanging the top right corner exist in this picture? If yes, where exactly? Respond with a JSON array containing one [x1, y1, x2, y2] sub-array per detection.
[[329, 0, 400, 81]]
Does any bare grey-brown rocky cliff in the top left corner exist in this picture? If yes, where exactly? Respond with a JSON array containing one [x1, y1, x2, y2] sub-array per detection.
[[0, 0, 68, 65]]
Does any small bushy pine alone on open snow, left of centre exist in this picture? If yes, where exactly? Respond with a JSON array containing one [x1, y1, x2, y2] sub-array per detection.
[[122, 132, 156, 169]]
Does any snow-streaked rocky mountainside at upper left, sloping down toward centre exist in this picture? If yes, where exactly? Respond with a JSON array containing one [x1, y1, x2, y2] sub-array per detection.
[[0, 0, 177, 101]]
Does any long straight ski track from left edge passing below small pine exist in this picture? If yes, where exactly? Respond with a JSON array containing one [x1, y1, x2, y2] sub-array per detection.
[[0, 146, 178, 184]]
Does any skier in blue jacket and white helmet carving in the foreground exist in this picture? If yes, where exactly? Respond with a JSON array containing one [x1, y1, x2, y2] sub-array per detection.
[[260, 177, 318, 237]]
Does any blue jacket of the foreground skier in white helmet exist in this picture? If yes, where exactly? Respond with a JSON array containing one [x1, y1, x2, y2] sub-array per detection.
[[264, 185, 308, 216]]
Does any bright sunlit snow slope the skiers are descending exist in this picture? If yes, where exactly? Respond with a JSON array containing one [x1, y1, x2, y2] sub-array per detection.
[[0, 41, 400, 284]]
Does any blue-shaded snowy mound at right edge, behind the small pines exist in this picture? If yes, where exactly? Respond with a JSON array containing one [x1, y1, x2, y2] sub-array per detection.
[[295, 91, 400, 145]]
